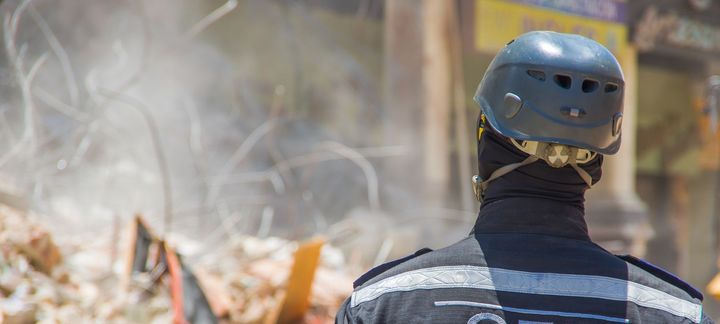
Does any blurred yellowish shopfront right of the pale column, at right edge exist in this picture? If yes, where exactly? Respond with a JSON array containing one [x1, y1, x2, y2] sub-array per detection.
[[627, 0, 720, 312]]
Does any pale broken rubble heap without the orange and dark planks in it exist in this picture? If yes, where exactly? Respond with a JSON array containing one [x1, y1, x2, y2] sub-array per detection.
[[0, 205, 352, 324]]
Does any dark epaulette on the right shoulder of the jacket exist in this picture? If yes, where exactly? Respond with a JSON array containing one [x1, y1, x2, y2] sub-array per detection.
[[617, 255, 703, 302]]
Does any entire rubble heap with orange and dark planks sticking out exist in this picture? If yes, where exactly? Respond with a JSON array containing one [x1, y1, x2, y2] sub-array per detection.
[[0, 205, 352, 324]]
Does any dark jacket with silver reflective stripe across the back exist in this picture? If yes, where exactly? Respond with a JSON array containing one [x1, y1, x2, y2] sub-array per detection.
[[336, 198, 712, 324]]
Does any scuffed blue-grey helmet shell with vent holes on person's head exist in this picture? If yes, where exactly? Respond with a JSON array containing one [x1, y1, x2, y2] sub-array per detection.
[[474, 31, 625, 154]]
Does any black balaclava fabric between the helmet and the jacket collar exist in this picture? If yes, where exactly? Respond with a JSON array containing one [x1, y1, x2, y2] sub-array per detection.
[[478, 127, 603, 213]]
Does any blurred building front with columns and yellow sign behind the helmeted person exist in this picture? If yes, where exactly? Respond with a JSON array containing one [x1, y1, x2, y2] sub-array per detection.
[[309, 0, 720, 286]]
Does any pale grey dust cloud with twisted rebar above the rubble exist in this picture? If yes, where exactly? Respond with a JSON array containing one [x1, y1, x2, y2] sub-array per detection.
[[0, 0, 467, 268]]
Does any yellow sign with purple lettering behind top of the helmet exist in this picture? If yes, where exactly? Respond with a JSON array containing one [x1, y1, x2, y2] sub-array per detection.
[[475, 0, 628, 58]]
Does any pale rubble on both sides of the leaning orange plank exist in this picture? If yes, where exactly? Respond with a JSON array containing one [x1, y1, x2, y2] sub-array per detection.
[[196, 237, 352, 323]]
